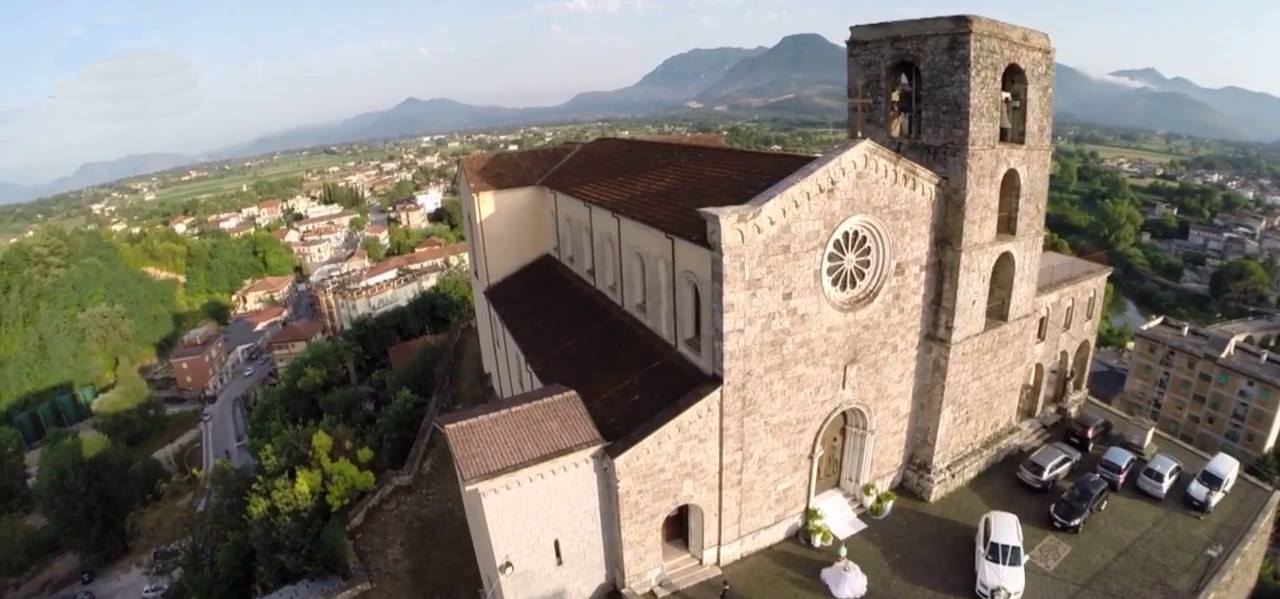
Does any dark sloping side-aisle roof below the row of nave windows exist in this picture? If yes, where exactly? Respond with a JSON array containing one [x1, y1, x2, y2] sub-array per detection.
[[485, 255, 719, 452]]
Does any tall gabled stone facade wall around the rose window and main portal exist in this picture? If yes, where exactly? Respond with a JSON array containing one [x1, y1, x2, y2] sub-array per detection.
[[709, 141, 940, 563]]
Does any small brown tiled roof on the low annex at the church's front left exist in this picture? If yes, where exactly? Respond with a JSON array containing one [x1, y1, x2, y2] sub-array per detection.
[[436, 385, 603, 483]]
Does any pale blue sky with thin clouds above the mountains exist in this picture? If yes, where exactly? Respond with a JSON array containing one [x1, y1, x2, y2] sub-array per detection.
[[0, 0, 1280, 183]]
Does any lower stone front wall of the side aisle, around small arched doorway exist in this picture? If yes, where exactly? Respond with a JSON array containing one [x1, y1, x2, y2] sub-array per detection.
[[613, 390, 721, 593]]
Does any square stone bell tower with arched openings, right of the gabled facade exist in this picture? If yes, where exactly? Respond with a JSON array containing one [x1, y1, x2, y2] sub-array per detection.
[[847, 15, 1053, 495]]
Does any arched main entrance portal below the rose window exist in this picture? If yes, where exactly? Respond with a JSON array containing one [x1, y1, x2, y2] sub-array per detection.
[[813, 408, 874, 497]]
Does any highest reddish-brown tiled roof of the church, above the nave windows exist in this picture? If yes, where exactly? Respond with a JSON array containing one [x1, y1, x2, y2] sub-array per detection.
[[463, 138, 814, 246]]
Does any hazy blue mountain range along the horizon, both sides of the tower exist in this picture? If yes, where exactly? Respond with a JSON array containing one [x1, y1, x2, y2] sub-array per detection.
[[0, 33, 1280, 204]]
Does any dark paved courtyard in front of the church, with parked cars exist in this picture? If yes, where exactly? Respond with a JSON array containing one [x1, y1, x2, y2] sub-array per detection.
[[677, 417, 1270, 599]]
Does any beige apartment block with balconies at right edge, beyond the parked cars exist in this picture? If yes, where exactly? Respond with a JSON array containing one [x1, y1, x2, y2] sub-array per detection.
[[1119, 317, 1280, 463]]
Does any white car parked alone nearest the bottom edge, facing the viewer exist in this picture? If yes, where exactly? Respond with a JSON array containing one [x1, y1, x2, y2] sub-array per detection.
[[973, 511, 1027, 599]]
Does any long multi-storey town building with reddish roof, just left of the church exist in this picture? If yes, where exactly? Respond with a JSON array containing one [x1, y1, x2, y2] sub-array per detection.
[[312, 243, 467, 334]]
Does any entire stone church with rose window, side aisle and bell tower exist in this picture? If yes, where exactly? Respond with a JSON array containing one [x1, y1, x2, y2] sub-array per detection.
[[438, 17, 1110, 599]]
